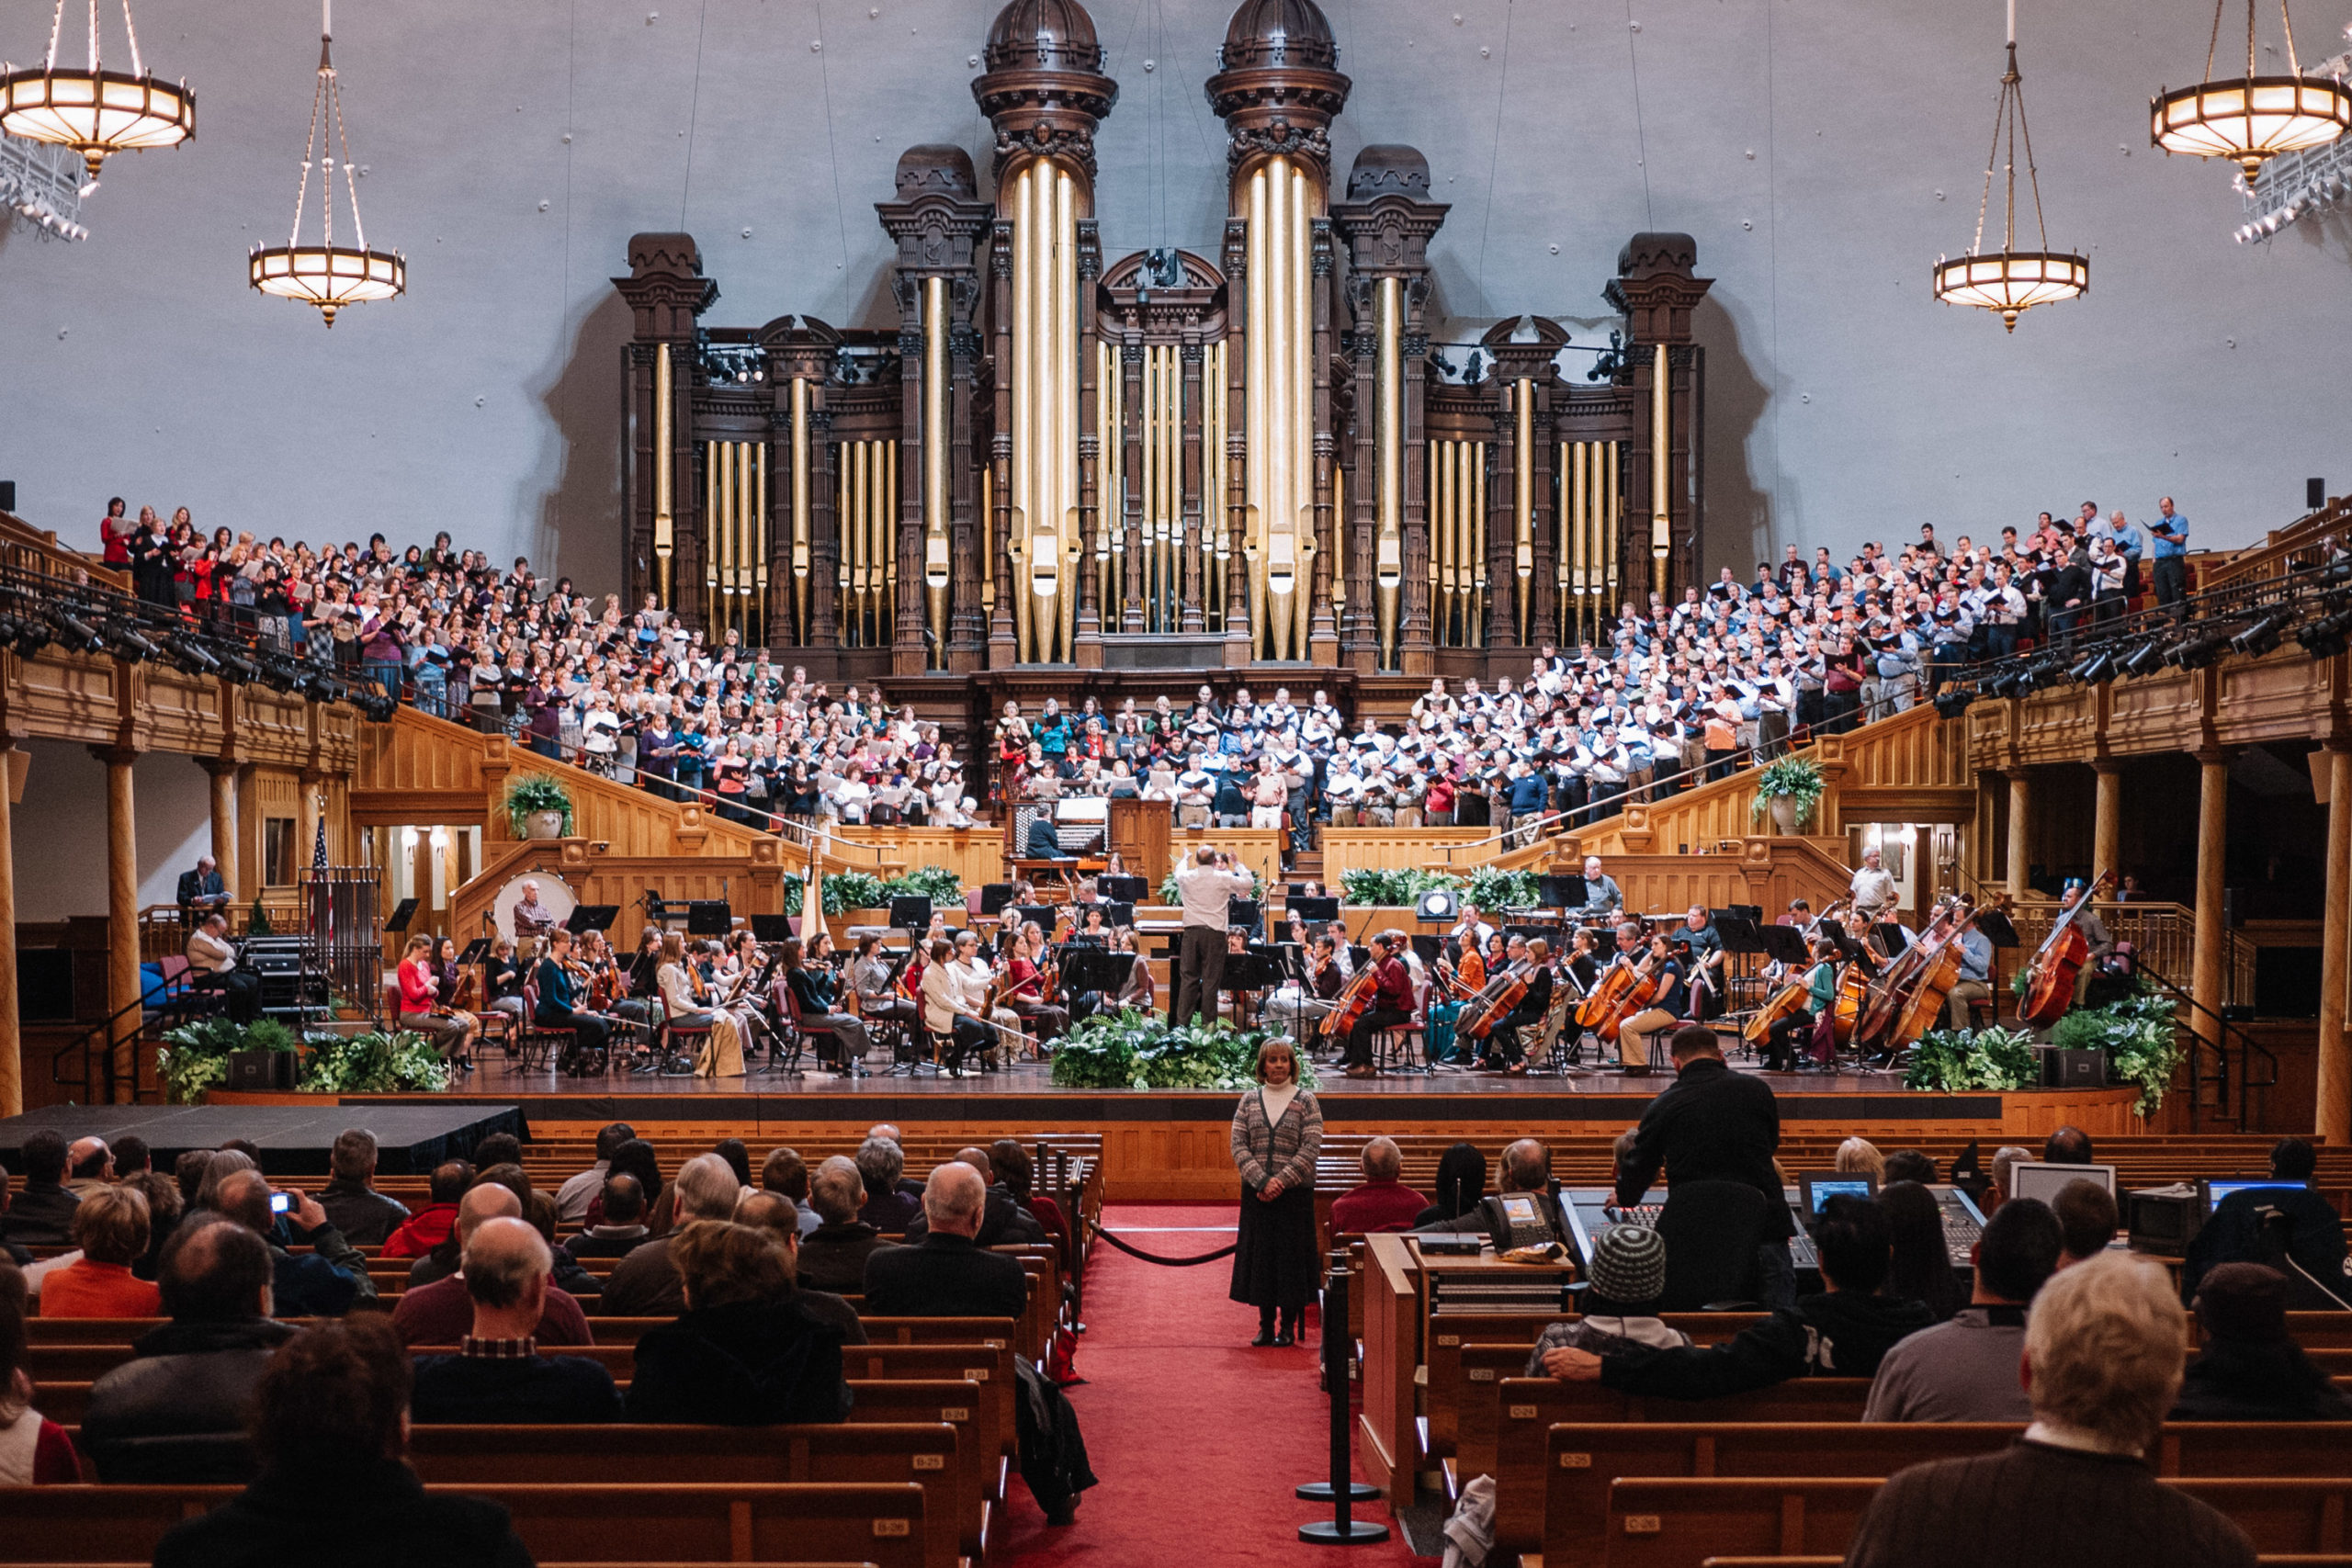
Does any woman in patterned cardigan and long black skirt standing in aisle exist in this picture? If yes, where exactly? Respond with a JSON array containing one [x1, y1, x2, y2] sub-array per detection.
[[1230, 1037, 1322, 1345]]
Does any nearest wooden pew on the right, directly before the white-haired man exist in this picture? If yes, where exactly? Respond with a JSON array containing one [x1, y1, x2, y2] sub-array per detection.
[[1609, 1476, 2352, 1568]]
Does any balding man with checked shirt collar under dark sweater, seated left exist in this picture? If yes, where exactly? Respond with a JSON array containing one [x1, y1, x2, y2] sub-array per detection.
[[412, 1218, 621, 1425]]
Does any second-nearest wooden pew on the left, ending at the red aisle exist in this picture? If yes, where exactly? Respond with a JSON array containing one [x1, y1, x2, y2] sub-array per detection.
[[409, 1422, 959, 1568]]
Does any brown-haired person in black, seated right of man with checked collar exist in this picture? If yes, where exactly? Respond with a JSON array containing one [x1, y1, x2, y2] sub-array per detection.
[[628, 1222, 851, 1427]]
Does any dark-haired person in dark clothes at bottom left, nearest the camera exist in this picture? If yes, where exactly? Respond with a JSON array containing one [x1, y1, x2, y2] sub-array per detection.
[[155, 1316, 532, 1568]]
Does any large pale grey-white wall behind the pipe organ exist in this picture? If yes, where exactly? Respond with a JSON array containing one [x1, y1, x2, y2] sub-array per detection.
[[0, 0, 2352, 583]]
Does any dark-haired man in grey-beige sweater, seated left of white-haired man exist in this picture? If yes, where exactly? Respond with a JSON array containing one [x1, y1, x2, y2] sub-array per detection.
[[1863, 1199, 2065, 1422]]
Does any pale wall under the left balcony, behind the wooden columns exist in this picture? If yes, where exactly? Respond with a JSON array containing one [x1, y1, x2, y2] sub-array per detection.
[[9, 738, 211, 921]]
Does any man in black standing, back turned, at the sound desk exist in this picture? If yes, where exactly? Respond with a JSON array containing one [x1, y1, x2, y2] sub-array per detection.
[[1616, 1022, 1797, 1307]]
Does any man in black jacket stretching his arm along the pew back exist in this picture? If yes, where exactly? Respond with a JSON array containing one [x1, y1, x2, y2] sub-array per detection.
[[1543, 1197, 1936, 1399]]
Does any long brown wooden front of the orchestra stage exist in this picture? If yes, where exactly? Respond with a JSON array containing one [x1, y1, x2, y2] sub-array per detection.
[[209, 1065, 2143, 1199]]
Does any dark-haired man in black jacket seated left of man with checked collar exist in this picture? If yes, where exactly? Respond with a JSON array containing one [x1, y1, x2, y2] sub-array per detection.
[[83, 1213, 294, 1483]]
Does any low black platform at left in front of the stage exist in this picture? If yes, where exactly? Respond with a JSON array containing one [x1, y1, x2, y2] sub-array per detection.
[[0, 1096, 532, 1176]]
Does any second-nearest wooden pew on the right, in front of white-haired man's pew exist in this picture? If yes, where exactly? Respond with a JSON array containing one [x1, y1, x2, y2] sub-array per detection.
[[1543, 1420, 2352, 1565]]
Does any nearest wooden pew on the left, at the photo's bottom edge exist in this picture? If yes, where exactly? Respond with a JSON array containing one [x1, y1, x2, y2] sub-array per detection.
[[7, 1481, 924, 1568]]
